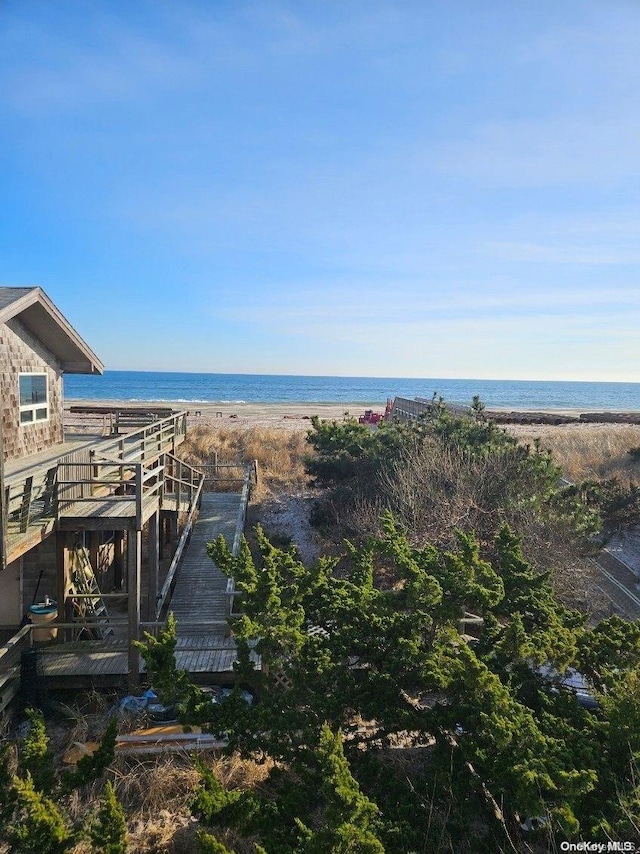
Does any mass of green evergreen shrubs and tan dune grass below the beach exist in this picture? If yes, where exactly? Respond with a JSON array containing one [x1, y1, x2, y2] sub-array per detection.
[[5, 417, 640, 854]]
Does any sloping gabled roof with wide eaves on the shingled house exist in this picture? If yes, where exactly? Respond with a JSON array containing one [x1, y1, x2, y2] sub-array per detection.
[[0, 287, 104, 374]]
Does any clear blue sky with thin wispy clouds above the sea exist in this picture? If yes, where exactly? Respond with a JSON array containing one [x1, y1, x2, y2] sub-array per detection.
[[0, 0, 640, 381]]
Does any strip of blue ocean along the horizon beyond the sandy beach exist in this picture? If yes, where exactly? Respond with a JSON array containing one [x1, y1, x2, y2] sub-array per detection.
[[64, 371, 640, 412]]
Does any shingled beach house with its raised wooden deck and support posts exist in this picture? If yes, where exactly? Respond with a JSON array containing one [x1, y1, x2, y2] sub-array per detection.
[[0, 287, 201, 688]]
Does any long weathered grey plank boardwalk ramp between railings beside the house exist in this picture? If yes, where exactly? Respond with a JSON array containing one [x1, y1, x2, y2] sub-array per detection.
[[169, 492, 241, 637]]
